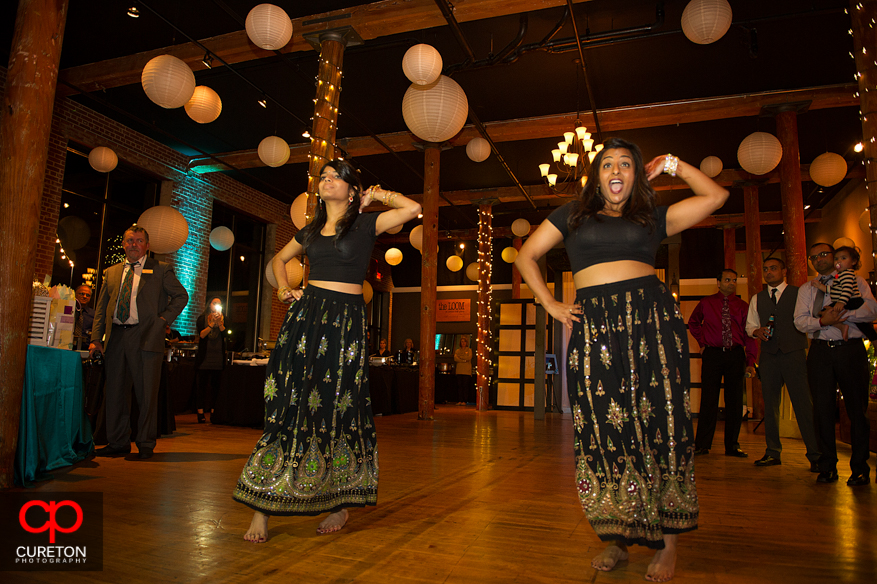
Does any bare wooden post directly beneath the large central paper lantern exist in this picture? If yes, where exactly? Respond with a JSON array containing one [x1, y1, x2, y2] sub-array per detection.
[[417, 144, 442, 420]]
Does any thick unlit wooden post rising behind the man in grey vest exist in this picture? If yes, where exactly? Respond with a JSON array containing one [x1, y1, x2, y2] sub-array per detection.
[[776, 111, 807, 286]]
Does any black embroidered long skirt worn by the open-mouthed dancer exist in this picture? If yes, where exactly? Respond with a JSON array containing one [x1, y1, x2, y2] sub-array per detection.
[[567, 276, 698, 549]]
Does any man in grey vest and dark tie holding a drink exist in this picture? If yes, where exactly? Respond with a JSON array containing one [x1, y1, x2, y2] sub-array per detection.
[[746, 258, 819, 472]]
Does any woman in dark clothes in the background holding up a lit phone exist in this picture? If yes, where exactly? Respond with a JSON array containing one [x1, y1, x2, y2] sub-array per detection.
[[195, 298, 225, 424]]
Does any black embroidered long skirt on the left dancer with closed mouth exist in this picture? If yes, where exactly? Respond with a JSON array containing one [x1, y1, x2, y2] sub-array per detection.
[[232, 286, 378, 515]]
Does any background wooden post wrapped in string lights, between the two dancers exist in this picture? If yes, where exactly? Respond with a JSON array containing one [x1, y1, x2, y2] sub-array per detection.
[[475, 204, 493, 412]]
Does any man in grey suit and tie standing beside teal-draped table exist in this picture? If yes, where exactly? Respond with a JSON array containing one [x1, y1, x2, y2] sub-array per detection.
[[89, 226, 189, 459]]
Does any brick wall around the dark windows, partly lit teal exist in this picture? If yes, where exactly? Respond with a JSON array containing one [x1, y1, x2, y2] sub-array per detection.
[[0, 67, 296, 338]]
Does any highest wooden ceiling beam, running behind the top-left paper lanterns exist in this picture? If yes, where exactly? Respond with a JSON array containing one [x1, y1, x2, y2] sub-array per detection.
[[57, 0, 591, 96]]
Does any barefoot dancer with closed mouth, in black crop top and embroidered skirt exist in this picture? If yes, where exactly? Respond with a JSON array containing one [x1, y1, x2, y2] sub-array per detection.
[[233, 160, 420, 543]]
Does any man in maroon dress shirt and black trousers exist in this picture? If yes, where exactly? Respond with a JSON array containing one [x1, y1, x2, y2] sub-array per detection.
[[688, 269, 758, 458]]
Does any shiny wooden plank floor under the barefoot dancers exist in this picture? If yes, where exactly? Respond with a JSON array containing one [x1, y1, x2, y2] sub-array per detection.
[[0, 406, 877, 584]]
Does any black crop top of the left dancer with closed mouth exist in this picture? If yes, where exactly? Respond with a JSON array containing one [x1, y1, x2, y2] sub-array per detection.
[[295, 213, 380, 285]]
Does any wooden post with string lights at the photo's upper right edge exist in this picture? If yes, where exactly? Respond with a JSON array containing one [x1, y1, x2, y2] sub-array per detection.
[[850, 0, 877, 278]]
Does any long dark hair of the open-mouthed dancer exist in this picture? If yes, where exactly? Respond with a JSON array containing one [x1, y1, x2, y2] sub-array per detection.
[[568, 138, 657, 231]]
